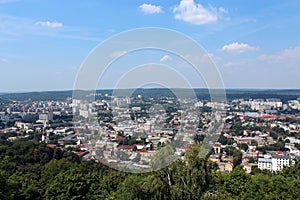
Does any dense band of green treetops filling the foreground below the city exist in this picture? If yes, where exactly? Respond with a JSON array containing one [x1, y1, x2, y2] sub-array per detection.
[[0, 140, 300, 199]]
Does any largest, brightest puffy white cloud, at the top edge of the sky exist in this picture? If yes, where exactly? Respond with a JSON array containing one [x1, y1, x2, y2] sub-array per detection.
[[173, 0, 227, 25]]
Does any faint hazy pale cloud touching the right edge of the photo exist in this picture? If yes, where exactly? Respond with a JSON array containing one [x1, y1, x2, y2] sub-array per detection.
[[257, 46, 300, 63]]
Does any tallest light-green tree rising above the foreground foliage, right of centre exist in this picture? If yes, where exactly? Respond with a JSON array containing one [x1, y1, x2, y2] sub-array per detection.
[[147, 144, 211, 199]]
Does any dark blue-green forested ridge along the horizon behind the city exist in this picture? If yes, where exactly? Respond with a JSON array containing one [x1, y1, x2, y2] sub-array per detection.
[[0, 88, 300, 102]]
